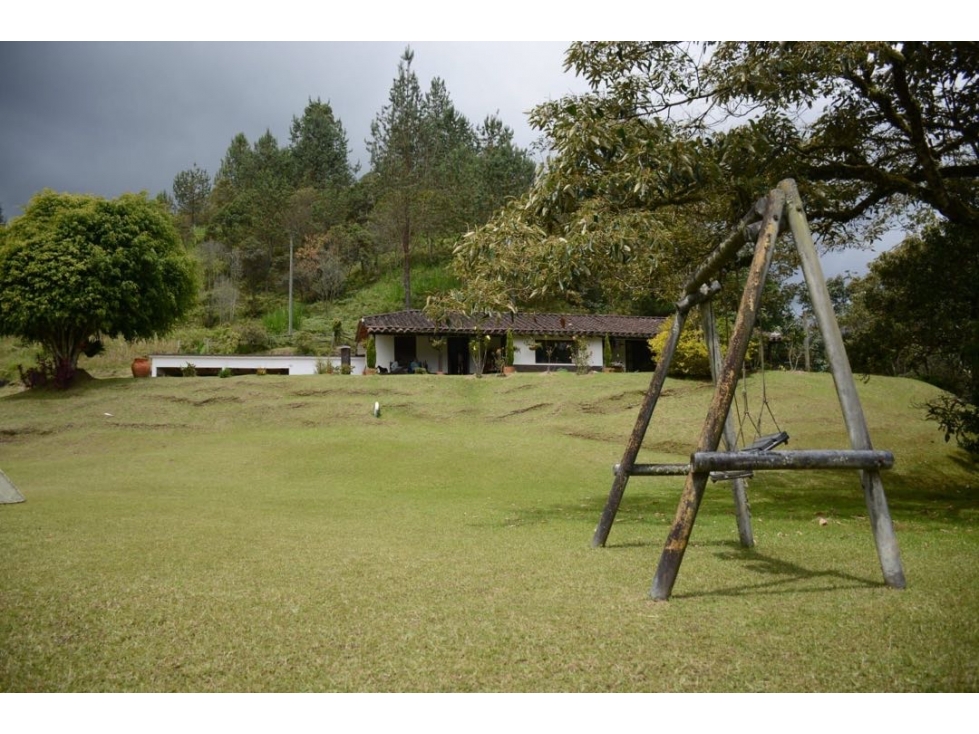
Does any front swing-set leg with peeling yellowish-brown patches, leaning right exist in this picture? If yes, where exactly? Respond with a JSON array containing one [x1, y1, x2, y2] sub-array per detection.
[[652, 189, 785, 601]]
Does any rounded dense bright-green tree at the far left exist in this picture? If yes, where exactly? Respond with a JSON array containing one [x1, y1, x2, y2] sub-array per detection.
[[0, 190, 196, 380]]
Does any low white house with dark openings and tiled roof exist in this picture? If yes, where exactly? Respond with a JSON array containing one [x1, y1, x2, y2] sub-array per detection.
[[357, 309, 664, 375]]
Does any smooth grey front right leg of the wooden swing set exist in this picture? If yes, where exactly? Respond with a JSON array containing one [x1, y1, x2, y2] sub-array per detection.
[[779, 180, 907, 589]]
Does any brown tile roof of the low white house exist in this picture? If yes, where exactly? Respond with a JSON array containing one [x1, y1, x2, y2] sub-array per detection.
[[357, 309, 664, 341]]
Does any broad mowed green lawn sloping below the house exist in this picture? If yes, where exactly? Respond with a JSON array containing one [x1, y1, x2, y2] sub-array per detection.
[[0, 373, 979, 692]]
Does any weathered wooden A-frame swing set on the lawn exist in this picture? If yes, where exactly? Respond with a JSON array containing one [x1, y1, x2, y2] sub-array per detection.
[[592, 179, 905, 601]]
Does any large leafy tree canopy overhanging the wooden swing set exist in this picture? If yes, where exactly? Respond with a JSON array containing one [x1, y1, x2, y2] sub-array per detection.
[[460, 42, 979, 314]]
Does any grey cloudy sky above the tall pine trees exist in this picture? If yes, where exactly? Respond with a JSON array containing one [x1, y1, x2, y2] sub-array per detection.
[[0, 42, 584, 218]]
